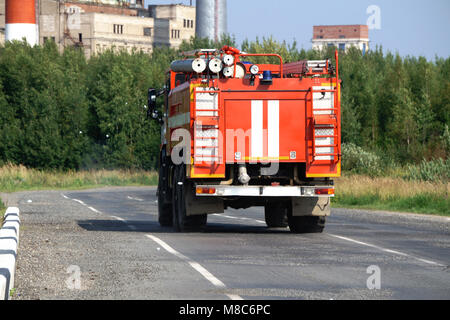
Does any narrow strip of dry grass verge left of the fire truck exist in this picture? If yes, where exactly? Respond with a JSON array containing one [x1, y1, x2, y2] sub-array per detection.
[[0, 165, 158, 192]]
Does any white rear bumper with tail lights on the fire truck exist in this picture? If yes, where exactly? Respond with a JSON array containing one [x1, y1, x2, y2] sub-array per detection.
[[195, 185, 334, 198]]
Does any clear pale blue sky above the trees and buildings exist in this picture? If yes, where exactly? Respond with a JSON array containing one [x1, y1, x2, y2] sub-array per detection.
[[145, 0, 450, 60]]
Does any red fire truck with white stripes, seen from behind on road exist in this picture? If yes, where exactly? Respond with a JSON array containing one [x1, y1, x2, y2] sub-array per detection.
[[148, 46, 341, 233]]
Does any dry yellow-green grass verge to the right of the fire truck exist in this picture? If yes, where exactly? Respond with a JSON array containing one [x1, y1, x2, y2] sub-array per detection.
[[332, 174, 450, 216]]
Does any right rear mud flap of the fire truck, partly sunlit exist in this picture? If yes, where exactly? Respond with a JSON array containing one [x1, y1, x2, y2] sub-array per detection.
[[291, 197, 331, 217]]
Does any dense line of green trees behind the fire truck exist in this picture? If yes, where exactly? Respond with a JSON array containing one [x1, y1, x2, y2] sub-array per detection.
[[0, 37, 450, 170]]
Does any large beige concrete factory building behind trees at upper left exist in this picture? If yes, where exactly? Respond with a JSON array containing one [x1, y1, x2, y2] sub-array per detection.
[[0, 0, 195, 57]]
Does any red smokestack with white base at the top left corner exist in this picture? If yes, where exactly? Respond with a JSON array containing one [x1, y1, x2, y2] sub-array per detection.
[[5, 0, 39, 46]]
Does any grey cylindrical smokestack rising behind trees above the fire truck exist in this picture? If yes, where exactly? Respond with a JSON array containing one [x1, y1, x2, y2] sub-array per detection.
[[195, 0, 227, 41]]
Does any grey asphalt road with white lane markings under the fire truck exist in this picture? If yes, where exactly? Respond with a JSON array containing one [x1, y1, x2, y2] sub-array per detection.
[[2, 188, 450, 300]]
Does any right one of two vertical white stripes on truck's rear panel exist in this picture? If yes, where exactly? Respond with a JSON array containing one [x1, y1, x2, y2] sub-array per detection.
[[267, 100, 280, 158]]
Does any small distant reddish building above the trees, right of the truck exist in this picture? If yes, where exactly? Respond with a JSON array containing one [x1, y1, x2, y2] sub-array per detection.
[[312, 25, 369, 53]]
